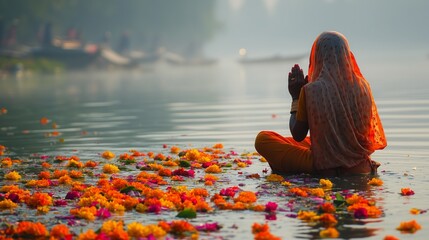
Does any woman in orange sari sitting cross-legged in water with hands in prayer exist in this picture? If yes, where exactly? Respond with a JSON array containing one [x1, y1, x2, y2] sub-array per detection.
[[255, 32, 387, 176]]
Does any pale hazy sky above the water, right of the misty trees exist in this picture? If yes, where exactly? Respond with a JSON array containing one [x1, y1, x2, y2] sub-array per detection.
[[207, 0, 429, 56]]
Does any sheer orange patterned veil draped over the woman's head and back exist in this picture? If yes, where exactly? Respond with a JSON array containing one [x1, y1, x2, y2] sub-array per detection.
[[304, 32, 387, 171]]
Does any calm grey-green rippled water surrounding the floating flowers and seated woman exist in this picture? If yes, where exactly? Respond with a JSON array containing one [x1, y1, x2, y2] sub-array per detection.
[[0, 57, 429, 239]]
